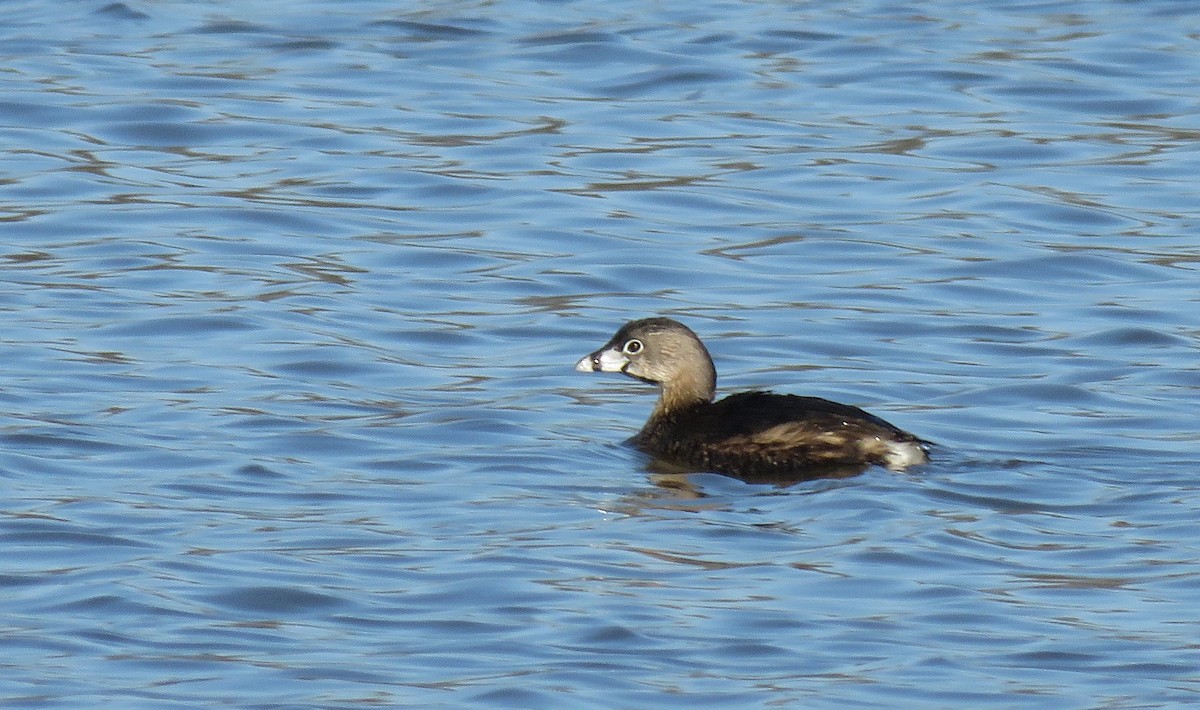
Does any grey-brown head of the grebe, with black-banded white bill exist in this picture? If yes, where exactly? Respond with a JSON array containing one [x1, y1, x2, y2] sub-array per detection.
[[575, 318, 716, 413]]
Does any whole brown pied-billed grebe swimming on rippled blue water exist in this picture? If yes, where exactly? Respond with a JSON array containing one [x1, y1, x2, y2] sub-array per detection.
[[575, 318, 929, 479]]
